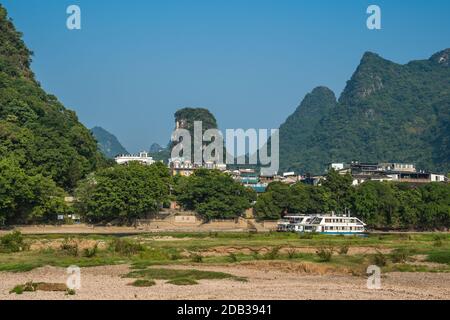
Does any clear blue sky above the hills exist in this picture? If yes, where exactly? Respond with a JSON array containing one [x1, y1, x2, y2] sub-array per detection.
[[0, 0, 450, 152]]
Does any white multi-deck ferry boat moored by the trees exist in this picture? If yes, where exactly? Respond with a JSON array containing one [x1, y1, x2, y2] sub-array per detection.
[[277, 214, 366, 235]]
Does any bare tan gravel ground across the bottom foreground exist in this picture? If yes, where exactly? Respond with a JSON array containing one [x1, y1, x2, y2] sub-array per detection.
[[0, 265, 450, 300]]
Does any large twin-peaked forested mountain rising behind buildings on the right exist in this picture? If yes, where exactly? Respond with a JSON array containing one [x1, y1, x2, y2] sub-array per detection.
[[280, 49, 450, 174]]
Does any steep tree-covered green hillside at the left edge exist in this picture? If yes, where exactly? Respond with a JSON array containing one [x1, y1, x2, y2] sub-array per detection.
[[0, 5, 103, 190]]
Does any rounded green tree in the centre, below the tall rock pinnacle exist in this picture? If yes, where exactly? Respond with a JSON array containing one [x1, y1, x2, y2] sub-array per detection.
[[176, 169, 255, 220]]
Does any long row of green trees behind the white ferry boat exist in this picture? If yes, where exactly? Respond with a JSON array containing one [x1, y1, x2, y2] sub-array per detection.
[[255, 172, 450, 230]]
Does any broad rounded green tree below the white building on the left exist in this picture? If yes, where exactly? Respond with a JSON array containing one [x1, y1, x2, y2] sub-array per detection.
[[76, 163, 171, 222]]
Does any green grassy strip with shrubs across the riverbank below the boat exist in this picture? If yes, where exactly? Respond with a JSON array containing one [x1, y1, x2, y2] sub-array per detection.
[[0, 232, 450, 274]]
